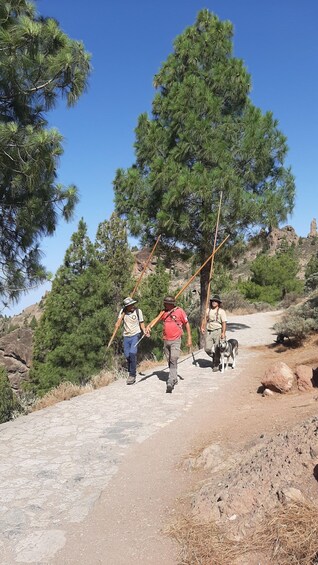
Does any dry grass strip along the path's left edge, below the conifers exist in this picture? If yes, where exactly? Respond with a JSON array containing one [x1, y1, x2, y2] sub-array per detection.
[[32, 371, 116, 412]]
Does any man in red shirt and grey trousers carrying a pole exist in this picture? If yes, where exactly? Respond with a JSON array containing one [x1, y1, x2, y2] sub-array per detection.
[[161, 296, 192, 392]]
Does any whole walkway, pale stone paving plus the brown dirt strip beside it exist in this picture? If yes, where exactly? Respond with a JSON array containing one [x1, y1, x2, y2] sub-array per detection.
[[0, 313, 317, 565]]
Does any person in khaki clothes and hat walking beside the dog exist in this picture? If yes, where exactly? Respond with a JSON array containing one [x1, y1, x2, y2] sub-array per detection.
[[201, 294, 226, 371]]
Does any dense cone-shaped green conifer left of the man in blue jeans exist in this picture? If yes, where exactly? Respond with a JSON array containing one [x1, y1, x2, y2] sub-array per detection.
[[30, 220, 114, 394]]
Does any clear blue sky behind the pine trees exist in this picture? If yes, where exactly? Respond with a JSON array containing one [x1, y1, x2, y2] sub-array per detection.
[[4, 0, 318, 315]]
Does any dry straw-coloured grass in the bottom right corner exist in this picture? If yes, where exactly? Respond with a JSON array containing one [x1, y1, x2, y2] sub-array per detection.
[[167, 502, 318, 565]]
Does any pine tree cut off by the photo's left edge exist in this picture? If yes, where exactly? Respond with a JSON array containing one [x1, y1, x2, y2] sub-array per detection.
[[0, 0, 90, 302]]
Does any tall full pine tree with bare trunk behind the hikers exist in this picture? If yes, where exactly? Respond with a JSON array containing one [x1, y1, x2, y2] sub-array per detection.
[[114, 10, 295, 322]]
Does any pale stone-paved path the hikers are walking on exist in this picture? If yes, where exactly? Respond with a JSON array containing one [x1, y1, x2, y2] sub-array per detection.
[[0, 313, 275, 565]]
